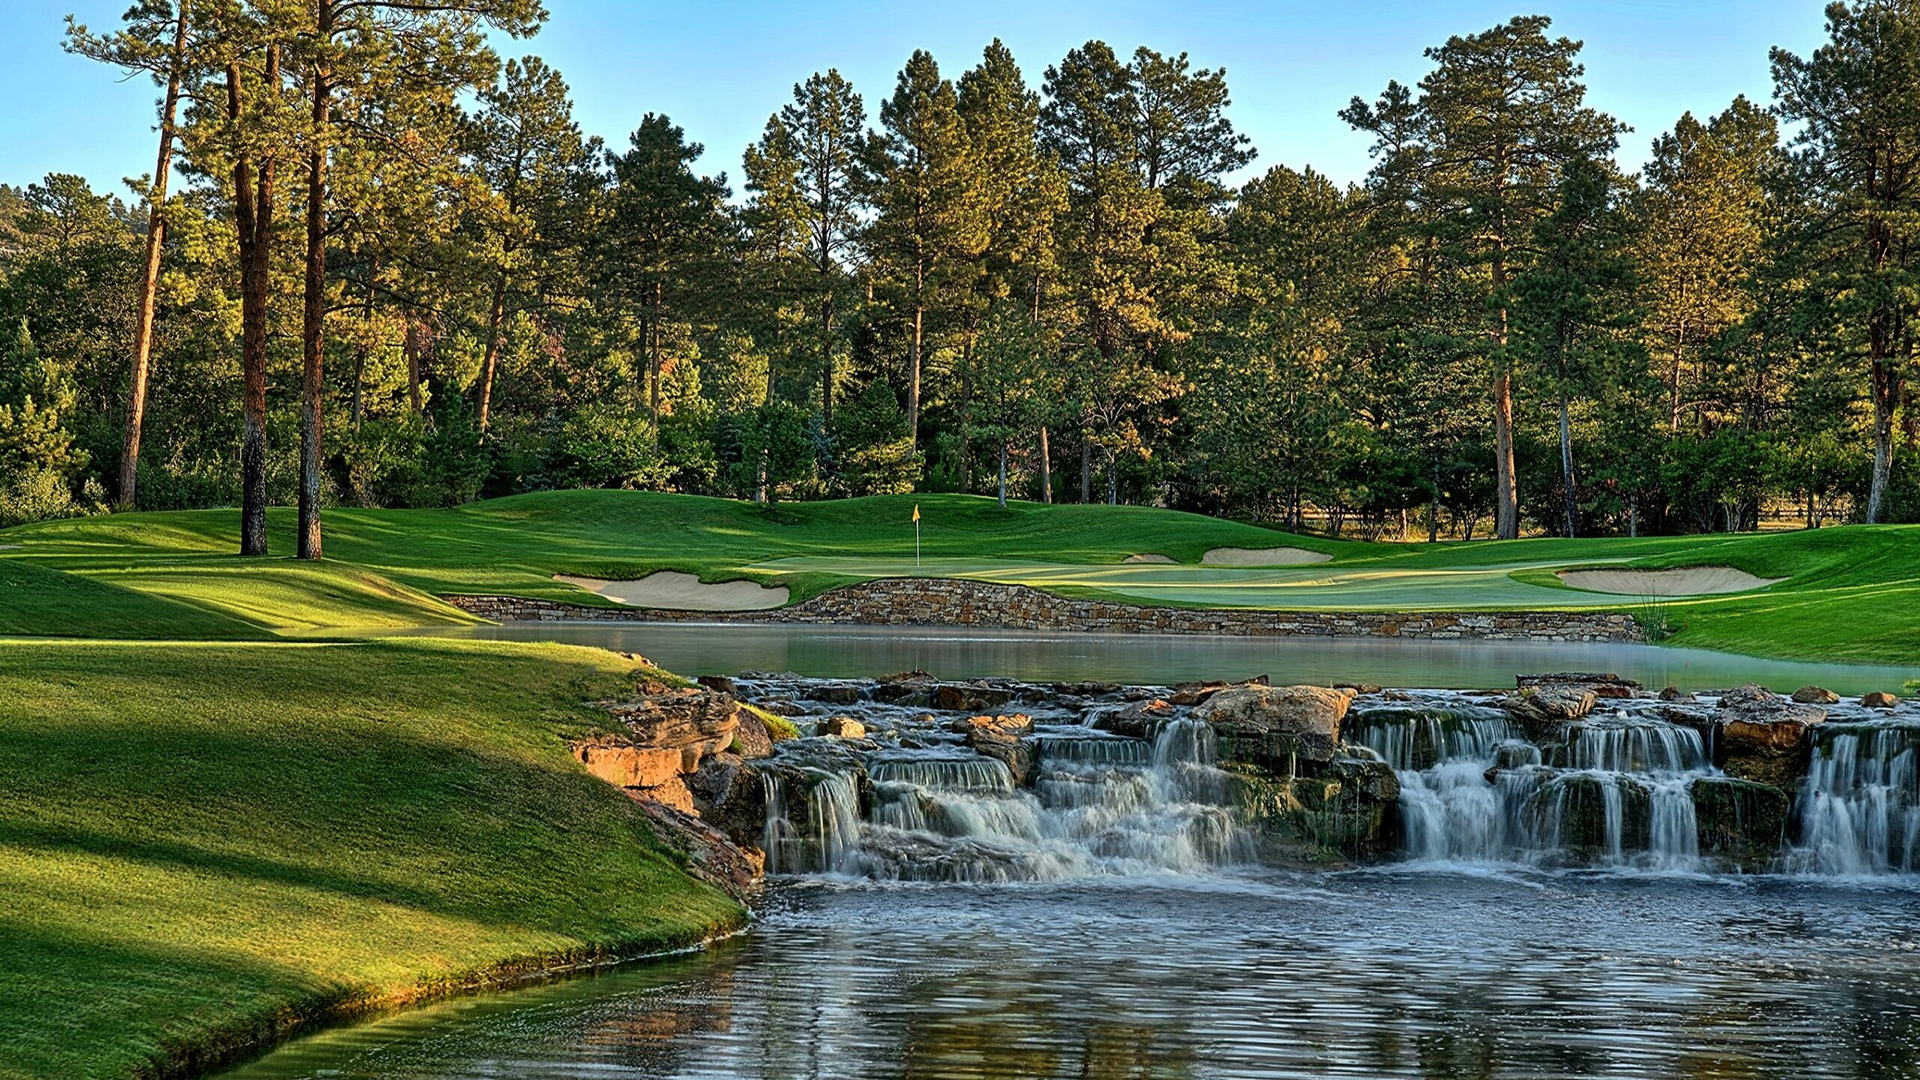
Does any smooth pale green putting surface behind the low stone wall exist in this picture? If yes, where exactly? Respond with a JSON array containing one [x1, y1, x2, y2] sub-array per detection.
[[747, 555, 1632, 611]]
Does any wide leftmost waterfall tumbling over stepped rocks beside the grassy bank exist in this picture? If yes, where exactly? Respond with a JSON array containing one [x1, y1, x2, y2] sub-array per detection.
[[766, 719, 1250, 882]]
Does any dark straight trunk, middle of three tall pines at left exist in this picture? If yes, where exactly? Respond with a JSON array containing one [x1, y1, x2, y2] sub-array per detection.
[[227, 44, 280, 555]]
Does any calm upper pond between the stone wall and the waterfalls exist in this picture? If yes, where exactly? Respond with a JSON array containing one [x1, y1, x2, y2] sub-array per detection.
[[393, 623, 1920, 694]]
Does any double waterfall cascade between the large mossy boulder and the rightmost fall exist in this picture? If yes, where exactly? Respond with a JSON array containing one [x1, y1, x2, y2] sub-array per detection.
[[1348, 701, 1715, 871]]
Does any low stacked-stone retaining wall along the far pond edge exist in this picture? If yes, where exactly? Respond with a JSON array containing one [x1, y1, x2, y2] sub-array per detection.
[[445, 578, 1645, 642]]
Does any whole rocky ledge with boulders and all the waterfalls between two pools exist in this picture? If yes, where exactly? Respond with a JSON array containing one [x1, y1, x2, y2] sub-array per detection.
[[574, 671, 1920, 890]]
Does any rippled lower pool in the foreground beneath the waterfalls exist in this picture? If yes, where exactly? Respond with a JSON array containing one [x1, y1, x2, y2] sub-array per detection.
[[214, 869, 1920, 1080]]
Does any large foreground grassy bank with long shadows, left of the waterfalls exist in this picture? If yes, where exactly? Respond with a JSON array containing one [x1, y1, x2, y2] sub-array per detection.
[[0, 640, 739, 1078]]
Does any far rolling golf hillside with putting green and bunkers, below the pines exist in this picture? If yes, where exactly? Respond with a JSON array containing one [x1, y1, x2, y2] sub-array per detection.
[[0, 490, 1920, 661]]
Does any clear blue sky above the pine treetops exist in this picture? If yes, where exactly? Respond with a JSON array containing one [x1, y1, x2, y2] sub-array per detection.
[[0, 0, 1824, 198]]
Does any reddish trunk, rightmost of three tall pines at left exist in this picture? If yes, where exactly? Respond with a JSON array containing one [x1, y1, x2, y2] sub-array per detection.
[[294, 8, 334, 559]]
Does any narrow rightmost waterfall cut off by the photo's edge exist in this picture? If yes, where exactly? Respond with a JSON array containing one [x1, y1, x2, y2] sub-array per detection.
[[1782, 721, 1920, 874]]
